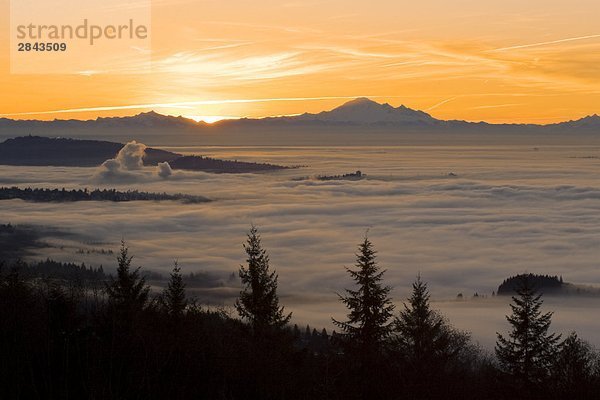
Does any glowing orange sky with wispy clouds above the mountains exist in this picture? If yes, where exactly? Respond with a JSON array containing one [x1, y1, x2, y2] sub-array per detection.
[[0, 0, 600, 123]]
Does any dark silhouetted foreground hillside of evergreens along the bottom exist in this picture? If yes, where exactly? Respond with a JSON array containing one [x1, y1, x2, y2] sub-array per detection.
[[0, 227, 600, 399]]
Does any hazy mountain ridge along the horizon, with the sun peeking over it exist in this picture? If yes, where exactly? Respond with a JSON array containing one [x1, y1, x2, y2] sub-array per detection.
[[0, 98, 600, 146]]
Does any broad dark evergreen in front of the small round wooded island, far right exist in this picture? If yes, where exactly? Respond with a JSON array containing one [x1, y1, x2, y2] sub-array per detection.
[[495, 275, 560, 396]]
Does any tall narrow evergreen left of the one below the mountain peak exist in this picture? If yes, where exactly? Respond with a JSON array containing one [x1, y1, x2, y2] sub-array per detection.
[[235, 226, 292, 332]]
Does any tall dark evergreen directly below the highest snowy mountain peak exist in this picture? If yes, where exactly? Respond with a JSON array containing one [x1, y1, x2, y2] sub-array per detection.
[[333, 236, 394, 354]]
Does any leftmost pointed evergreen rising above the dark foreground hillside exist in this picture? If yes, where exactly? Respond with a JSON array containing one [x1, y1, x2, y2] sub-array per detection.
[[106, 240, 150, 312]]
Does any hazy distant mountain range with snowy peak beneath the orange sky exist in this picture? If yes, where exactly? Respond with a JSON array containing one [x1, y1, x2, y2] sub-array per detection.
[[0, 98, 600, 144]]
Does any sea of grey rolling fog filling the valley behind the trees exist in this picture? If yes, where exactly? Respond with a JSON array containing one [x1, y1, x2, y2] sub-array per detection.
[[0, 145, 600, 348]]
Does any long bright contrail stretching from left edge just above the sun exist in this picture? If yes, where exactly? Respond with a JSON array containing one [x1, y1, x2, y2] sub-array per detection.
[[0, 95, 401, 117]]
